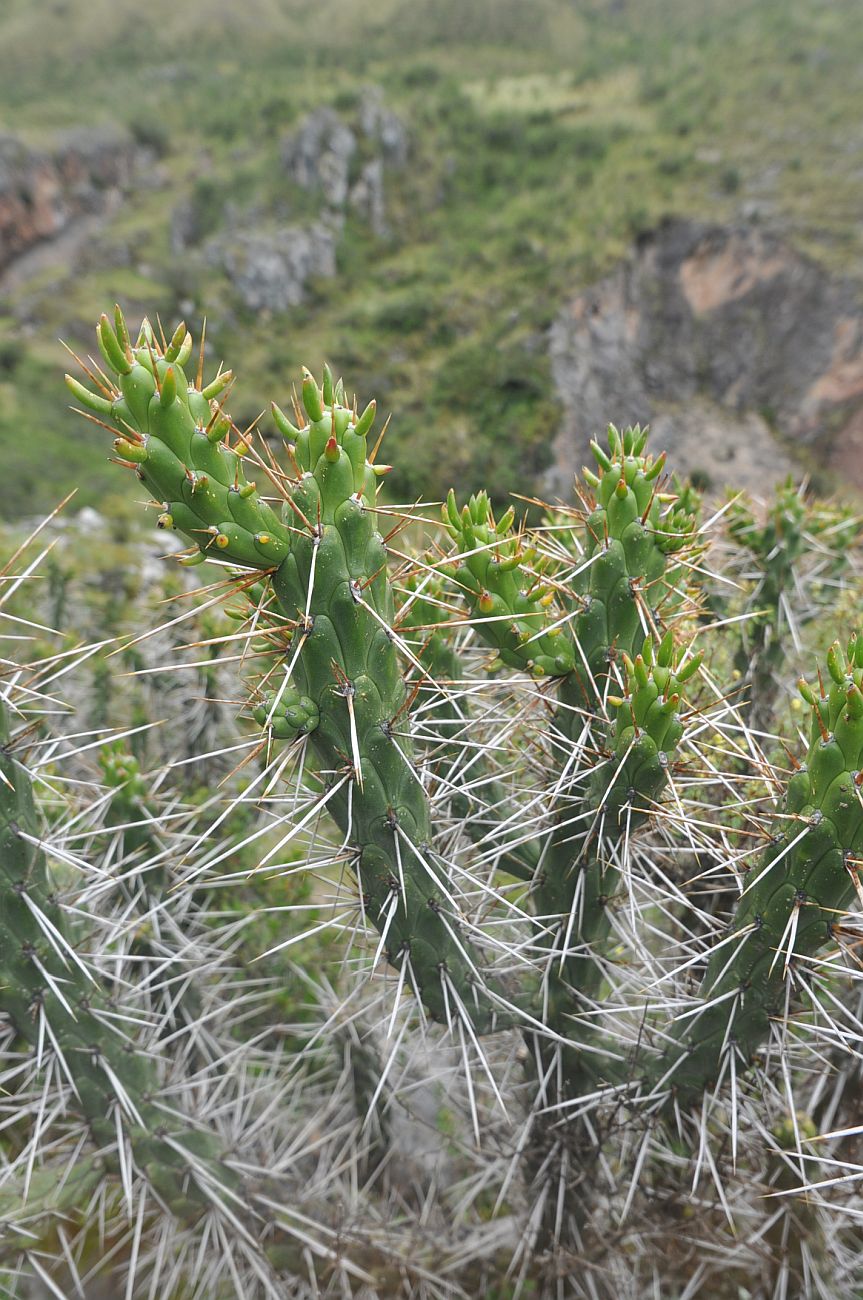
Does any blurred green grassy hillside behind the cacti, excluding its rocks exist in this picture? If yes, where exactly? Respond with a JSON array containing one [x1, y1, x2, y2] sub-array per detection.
[[0, 0, 863, 516]]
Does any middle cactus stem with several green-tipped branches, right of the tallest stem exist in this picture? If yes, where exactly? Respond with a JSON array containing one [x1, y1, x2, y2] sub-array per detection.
[[443, 426, 698, 1088]]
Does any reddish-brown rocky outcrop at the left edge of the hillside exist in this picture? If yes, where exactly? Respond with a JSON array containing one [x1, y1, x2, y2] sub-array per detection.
[[0, 127, 142, 270]]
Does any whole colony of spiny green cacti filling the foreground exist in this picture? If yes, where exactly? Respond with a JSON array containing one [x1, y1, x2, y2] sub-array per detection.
[[0, 301, 863, 1297]]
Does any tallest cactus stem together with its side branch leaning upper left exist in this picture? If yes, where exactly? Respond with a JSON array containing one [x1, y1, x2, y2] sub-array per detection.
[[74, 317, 504, 1031]]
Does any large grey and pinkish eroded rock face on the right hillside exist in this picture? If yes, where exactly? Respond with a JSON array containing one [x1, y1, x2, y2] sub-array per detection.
[[546, 220, 863, 495]]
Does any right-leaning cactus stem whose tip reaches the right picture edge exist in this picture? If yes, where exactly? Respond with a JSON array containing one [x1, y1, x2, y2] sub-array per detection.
[[656, 636, 863, 1099]]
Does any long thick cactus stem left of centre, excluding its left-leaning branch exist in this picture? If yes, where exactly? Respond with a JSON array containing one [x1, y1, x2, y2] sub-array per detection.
[[270, 372, 512, 1031]]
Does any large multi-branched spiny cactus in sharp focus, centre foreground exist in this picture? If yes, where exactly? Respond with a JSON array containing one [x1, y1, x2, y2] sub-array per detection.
[[60, 313, 863, 1296]]
